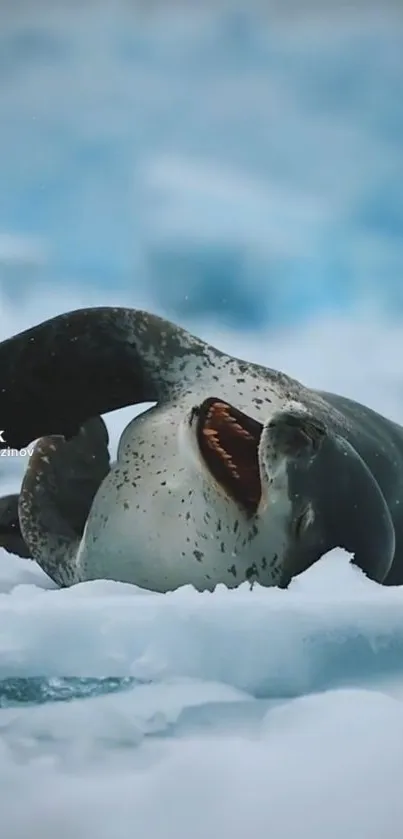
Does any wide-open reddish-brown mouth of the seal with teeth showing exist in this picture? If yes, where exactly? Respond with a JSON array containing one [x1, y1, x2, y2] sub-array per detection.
[[197, 398, 263, 515]]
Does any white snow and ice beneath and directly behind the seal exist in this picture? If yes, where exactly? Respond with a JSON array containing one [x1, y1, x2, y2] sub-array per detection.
[[0, 291, 403, 839]]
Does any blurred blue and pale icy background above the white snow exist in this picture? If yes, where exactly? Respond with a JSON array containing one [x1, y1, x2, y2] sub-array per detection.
[[0, 0, 403, 331]]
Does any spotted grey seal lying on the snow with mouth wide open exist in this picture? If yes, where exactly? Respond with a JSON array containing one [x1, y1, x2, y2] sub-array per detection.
[[0, 307, 403, 592]]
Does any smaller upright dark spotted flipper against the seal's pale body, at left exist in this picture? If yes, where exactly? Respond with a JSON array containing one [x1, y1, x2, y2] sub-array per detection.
[[18, 417, 110, 586]]
